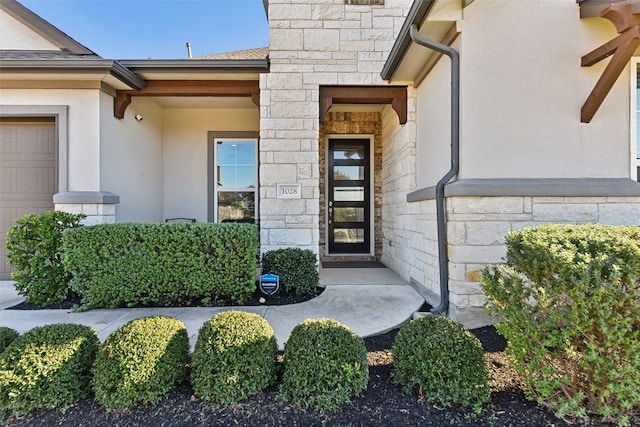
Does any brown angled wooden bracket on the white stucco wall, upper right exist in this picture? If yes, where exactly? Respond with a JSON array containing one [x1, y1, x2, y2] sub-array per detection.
[[580, 4, 640, 123]]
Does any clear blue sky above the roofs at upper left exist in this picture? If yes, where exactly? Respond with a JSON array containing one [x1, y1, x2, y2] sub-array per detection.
[[19, 0, 269, 59]]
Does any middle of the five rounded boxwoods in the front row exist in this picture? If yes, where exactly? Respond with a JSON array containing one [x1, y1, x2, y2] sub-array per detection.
[[191, 310, 278, 405]]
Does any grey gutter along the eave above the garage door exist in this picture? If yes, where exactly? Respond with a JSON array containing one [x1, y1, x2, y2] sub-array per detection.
[[0, 59, 146, 90]]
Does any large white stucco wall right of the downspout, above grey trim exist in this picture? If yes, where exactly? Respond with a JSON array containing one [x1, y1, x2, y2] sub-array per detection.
[[459, 0, 630, 178]]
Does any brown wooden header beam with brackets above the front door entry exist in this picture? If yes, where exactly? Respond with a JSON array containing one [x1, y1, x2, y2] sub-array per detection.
[[319, 86, 407, 125]]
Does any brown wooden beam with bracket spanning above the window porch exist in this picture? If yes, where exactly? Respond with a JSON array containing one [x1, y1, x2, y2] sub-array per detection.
[[113, 80, 260, 119]]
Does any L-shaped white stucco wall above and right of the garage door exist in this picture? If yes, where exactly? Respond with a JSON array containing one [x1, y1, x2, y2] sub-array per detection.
[[0, 89, 102, 191]]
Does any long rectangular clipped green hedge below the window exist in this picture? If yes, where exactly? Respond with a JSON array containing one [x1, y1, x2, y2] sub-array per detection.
[[64, 223, 258, 308]]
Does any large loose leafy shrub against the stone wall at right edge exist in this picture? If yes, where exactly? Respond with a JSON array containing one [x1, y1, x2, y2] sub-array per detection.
[[482, 224, 640, 424]]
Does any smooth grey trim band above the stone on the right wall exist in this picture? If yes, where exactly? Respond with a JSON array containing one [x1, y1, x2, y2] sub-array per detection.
[[407, 178, 640, 202]]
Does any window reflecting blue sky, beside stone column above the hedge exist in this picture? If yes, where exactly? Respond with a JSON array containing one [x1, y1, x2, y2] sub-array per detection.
[[209, 137, 258, 223]]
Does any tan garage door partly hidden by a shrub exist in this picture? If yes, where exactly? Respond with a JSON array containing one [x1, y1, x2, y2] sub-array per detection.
[[0, 117, 58, 280]]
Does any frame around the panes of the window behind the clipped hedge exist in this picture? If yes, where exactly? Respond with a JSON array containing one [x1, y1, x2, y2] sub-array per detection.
[[207, 131, 260, 224]]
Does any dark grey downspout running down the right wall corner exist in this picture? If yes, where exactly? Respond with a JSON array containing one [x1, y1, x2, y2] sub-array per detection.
[[409, 24, 460, 314]]
